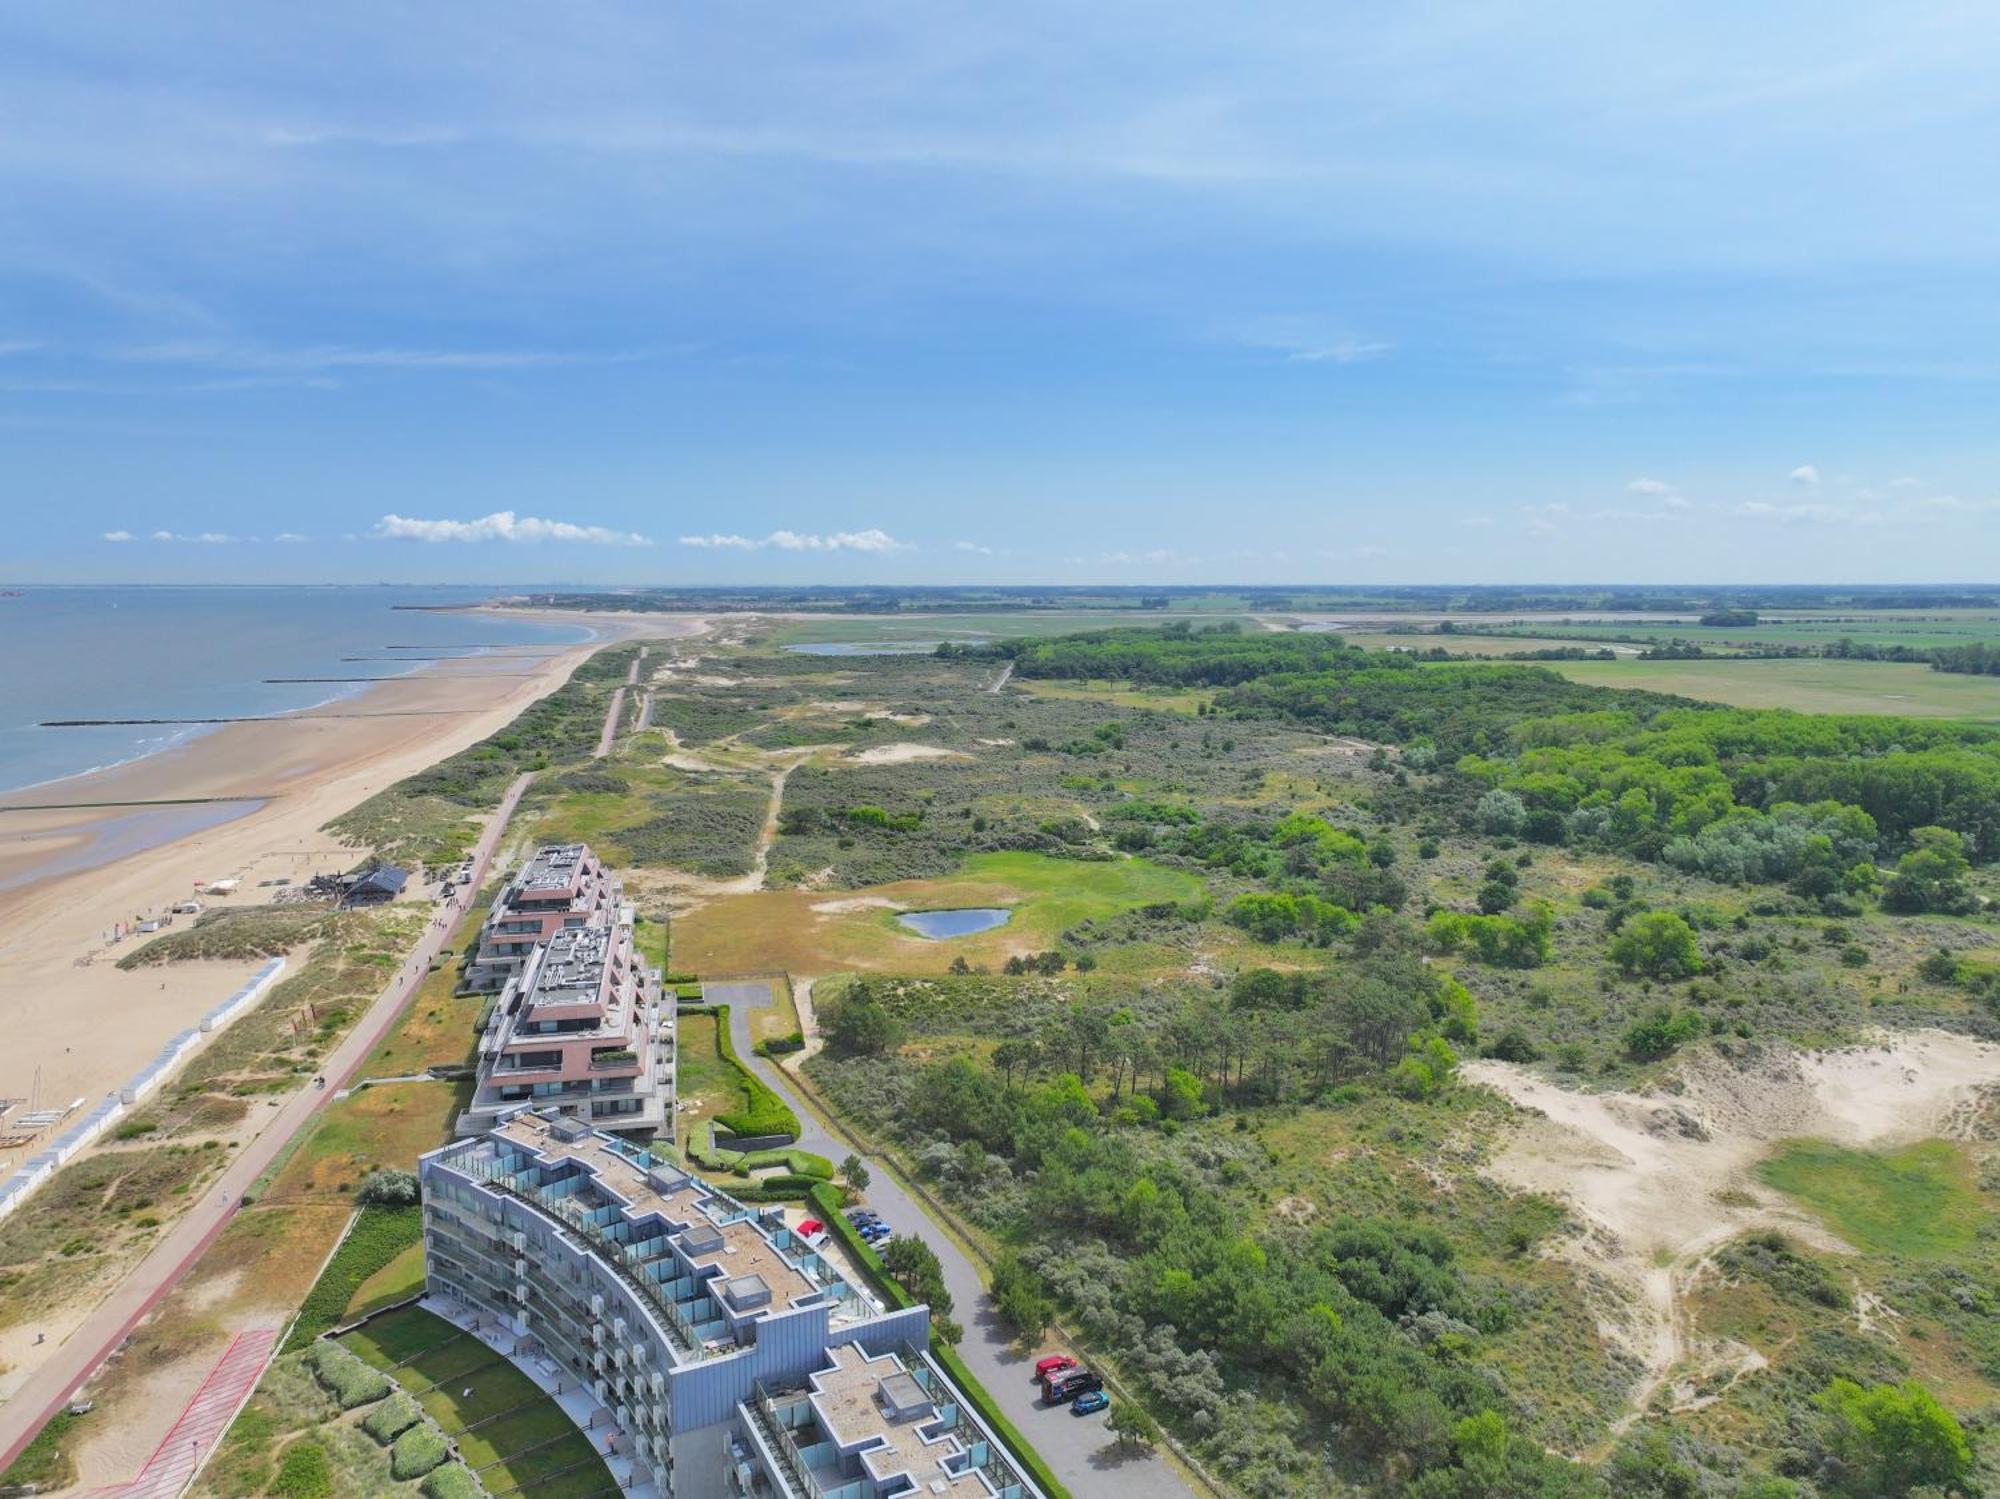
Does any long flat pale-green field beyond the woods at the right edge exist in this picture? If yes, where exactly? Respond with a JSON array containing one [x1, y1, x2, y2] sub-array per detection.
[[1548, 660, 2000, 720]]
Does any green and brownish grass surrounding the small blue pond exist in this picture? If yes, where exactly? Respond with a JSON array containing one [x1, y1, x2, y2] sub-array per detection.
[[674, 853, 1202, 975]]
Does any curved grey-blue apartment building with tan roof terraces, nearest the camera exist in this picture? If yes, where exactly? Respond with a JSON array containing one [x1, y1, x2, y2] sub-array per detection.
[[420, 1109, 1042, 1499]]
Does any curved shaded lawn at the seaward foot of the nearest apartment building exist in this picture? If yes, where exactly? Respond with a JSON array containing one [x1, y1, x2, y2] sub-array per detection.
[[342, 1307, 616, 1499]]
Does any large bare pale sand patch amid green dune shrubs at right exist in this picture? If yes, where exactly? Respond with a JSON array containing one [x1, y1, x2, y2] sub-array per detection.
[[1464, 1031, 2000, 1421]]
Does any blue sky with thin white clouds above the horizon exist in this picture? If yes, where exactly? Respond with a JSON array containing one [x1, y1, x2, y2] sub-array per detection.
[[0, 0, 2000, 582]]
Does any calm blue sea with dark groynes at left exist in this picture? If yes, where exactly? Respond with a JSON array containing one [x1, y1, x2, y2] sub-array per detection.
[[0, 588, 592, 789]]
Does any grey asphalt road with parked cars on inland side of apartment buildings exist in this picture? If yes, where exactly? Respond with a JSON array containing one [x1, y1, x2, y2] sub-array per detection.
[[728, 985, 1204, 1499]]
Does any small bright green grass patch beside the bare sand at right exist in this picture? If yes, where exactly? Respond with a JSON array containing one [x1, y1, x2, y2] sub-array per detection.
[[1758, 1139, 1990, 1259]]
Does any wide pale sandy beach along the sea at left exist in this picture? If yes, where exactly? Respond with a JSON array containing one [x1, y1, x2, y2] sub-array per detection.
[[0, 616, 706, 1173]]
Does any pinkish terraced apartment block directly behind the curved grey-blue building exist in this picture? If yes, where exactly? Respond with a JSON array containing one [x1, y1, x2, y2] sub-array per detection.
[[458, 911, 674, 1135]]
